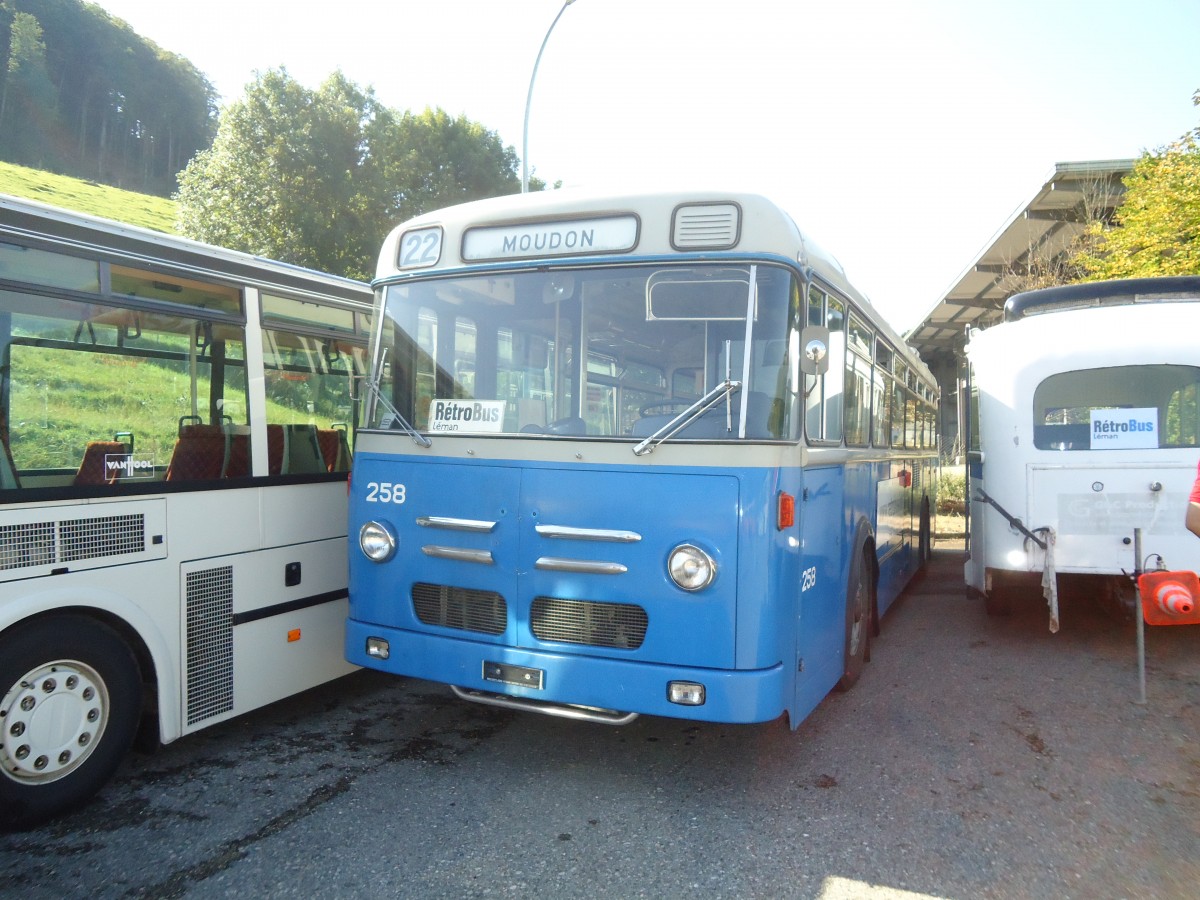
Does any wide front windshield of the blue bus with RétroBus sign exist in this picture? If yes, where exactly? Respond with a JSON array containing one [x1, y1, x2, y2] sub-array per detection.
[[368, 264, 803, 440]]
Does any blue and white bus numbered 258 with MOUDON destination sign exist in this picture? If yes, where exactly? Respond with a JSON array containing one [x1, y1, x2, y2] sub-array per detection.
[[346, 191, 937, 727]]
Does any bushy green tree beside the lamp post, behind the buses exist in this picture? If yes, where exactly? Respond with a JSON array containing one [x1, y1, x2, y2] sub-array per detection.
[[176, 68, 520, 280]]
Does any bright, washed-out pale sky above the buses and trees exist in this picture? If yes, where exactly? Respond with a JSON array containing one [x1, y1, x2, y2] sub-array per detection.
[[88, 0, 1200, 330]]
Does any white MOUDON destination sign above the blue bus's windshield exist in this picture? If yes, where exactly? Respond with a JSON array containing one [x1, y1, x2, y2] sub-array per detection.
[[462, 216, 637, 262]]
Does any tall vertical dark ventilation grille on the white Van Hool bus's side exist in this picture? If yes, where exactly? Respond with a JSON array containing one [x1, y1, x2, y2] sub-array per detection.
[[186, 565, 233, 725]]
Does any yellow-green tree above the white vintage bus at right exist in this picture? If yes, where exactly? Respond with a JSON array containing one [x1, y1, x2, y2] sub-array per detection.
[[1079, 91, 1200, 281]]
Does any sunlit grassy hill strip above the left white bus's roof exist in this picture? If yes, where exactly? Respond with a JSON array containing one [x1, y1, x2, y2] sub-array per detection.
[[0, 162, 175, 234]]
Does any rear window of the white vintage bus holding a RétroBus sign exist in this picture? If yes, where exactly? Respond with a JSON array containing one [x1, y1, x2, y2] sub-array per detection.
[[1033, 365, 1200, 450]]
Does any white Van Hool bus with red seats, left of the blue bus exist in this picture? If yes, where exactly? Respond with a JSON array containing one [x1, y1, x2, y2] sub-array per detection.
[[0, 197, 371, 828]]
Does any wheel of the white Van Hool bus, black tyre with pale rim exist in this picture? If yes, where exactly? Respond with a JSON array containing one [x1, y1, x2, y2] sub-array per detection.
[[0, 616, 142, 830]]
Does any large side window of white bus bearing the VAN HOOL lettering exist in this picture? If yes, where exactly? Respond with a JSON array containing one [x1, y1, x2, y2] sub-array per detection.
[[0, 286, 248, 488]]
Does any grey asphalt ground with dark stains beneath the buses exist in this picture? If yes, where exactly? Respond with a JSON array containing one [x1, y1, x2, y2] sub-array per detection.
[[0, 547, 1200, 900]]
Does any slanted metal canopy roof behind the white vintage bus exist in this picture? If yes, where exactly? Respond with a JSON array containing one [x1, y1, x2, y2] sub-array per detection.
[[907, 160, 1136, 367]]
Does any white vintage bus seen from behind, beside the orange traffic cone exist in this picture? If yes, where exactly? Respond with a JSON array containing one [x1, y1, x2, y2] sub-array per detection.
[[966, 277, 1200, 630]]
